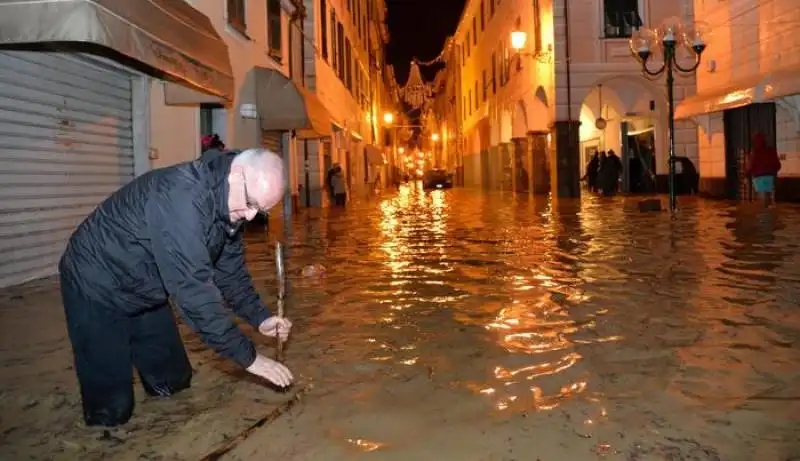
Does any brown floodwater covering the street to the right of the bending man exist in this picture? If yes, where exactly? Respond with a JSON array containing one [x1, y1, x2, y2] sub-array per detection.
[[236, 184, 800, 461]]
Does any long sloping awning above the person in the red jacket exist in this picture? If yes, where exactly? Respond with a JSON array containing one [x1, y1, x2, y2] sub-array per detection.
[[675, 68, 800, 120]]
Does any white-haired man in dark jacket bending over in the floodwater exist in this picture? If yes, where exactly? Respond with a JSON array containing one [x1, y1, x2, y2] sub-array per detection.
[[59, 149, 293, 427]]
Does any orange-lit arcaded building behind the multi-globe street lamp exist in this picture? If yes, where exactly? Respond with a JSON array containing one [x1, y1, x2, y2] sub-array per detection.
[[438, 0, 698, 197]]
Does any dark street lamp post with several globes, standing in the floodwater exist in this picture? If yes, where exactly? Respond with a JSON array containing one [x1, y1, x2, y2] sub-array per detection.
[[630, 19, 706, 212]]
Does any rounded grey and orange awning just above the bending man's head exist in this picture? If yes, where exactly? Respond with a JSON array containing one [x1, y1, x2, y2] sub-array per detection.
[[255, 67, 333, 138]]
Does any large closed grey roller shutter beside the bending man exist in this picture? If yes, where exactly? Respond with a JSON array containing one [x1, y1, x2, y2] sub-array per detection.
[[0, 51, 134, 287]]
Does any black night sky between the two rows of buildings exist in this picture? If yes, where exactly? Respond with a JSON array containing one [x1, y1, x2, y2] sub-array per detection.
[[386, 0, 465, 85]]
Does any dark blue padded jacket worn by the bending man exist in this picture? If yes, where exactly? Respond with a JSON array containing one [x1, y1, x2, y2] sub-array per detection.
[[59, 153, 271, 367]]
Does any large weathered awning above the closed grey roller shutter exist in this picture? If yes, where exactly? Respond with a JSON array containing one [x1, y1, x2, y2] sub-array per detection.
[[0, 0, 234, 102]]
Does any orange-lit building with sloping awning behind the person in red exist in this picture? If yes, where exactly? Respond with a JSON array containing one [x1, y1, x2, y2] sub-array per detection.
[[676, 0, 800, 201]]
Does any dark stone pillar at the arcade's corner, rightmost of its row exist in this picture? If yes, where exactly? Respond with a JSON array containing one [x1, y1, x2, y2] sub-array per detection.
[[550, 121, 581, 198]]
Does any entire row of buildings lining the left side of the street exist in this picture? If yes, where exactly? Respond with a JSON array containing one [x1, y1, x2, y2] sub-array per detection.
[[0, 0, 391, 287]]
